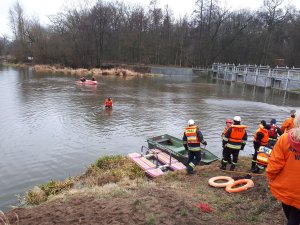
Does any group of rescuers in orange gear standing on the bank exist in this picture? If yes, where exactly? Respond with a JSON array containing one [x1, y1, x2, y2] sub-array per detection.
[[182, 110, 300, 225]]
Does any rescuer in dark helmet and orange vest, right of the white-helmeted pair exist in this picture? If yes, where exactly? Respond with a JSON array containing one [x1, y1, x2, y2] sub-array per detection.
[[251, 120, 269, 173]]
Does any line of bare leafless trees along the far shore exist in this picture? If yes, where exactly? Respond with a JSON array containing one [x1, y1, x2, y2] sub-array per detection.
[[0, 0, 300, 68]]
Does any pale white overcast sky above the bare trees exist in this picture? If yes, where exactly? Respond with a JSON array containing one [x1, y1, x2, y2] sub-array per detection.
[[0, 0, 300, 36]]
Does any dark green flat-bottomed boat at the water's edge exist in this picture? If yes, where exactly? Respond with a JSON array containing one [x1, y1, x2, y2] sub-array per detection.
[[147, 134, 219, 164]]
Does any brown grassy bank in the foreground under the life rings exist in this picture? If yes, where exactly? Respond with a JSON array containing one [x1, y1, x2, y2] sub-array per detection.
[[1, 156, 285, 225]]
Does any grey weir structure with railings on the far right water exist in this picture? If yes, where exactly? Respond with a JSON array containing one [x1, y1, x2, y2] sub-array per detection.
[[210, 63, 300, 91]]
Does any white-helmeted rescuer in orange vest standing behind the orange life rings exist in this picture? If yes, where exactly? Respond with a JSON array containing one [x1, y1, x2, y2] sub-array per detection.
[[221, 116, 247, 171]]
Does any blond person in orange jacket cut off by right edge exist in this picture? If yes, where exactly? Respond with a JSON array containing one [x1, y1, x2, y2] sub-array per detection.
[[266, 114, 300, 225]]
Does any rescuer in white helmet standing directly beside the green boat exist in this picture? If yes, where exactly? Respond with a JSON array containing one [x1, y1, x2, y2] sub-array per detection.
[[182, 119, 207, 174]]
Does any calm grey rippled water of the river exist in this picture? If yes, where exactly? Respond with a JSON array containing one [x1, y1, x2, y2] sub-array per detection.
[[0, 67, 299, 211]]
